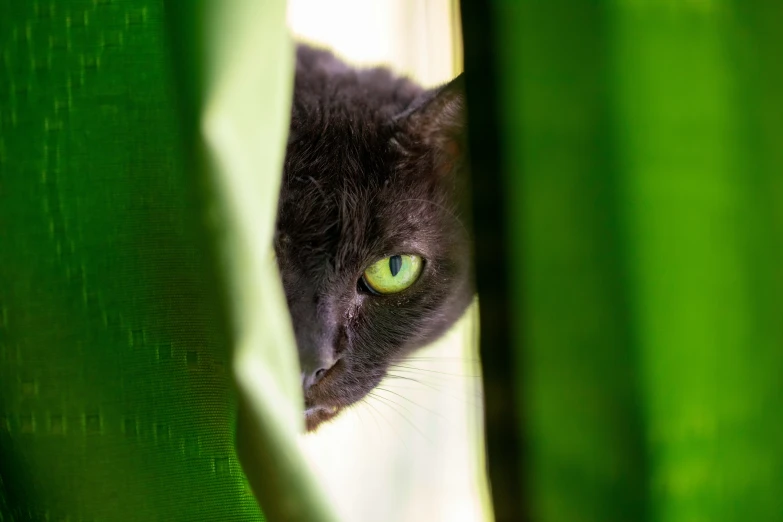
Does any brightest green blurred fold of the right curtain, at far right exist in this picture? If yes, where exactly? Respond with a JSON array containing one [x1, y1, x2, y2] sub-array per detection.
[[613, 2, 783, 521]]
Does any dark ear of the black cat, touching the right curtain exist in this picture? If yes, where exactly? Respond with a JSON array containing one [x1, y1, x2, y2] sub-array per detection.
[[395, 74, 466, 174]]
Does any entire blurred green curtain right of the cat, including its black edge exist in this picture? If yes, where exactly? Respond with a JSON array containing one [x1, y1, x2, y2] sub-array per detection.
[[462, 0, 783, 522]]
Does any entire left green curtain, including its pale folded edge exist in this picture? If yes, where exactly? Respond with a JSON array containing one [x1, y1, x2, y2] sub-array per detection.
[[0, 0, 330, 521]]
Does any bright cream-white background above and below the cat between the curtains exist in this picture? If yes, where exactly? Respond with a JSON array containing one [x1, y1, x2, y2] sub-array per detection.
[[288, 0, 490, 522]]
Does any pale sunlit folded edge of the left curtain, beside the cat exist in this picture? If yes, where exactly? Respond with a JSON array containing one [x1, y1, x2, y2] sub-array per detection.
[[166, 0, 335, 522]]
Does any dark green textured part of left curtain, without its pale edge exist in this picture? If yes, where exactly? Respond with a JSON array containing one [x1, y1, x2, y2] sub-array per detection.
[[0, 0, 263, 521]]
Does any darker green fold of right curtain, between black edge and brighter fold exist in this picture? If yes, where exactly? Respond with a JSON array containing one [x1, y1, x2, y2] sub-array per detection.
[[497, 1, 646, 522]]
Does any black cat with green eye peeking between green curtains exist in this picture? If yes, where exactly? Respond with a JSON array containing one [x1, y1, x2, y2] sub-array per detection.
[[275, 45, 473, 430]]
